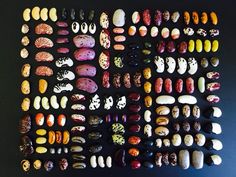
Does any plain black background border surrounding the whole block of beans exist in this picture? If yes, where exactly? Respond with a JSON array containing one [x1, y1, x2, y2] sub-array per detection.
[[0, 0, 236, 177]]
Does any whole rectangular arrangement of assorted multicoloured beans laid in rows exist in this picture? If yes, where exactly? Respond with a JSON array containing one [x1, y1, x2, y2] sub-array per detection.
[[19, 6, 223, 172]]
